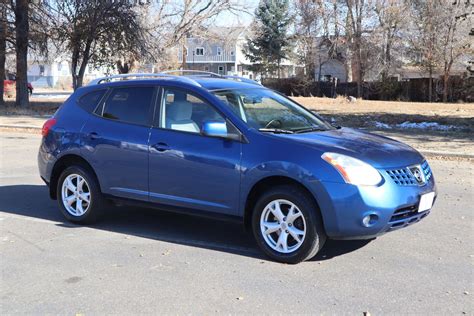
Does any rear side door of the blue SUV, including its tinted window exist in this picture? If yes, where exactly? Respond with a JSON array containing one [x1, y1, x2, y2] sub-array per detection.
[[83, 86, 157, 201]]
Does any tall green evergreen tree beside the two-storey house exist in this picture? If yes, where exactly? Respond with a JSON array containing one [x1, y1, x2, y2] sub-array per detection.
[[244, 0, 292, 78]]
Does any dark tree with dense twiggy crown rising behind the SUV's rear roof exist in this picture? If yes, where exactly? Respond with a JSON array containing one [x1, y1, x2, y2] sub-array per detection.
[[49, 0, 146, 89]]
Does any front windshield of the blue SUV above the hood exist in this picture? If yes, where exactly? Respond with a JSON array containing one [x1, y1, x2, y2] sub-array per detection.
[[213, 88, 334, 133]]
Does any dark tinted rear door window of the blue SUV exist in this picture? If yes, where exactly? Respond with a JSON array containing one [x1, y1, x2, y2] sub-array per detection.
[[102, 87, 154, 125]]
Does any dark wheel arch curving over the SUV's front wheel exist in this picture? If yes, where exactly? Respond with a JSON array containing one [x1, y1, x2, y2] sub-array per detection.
[[244, 175, 324, 231]]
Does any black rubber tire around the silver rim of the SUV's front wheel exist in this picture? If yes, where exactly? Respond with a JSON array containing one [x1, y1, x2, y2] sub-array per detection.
[[252, 186, 326, 263]]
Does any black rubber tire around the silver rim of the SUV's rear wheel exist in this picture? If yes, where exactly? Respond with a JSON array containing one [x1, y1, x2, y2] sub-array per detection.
[[56, 166, 102, 224]]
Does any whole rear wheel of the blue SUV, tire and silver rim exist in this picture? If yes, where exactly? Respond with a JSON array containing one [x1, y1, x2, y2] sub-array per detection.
[[56, 166, 107, 224]]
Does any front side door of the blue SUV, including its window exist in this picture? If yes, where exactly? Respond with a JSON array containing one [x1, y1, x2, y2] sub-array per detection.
[[149, 88, 242, 215]]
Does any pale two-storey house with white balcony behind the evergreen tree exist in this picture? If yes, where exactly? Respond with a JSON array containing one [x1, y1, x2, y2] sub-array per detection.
[[177, 27, 299, 80]]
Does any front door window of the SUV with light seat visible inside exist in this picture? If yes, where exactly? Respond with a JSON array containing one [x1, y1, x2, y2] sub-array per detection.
[[160, 89, 225, 133]]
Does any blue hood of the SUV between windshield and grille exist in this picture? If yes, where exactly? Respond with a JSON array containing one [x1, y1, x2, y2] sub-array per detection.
[[280, 128, 423, 168]]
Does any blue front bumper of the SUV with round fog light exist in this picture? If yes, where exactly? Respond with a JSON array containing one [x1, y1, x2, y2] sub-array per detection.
[[315, 176, 437, 239]]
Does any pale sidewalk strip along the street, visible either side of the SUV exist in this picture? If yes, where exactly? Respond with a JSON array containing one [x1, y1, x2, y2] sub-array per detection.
[[0, 115, 474, 159]]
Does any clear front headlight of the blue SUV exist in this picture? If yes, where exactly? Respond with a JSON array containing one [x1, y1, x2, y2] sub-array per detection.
[[321, 153, 382, 185]]
